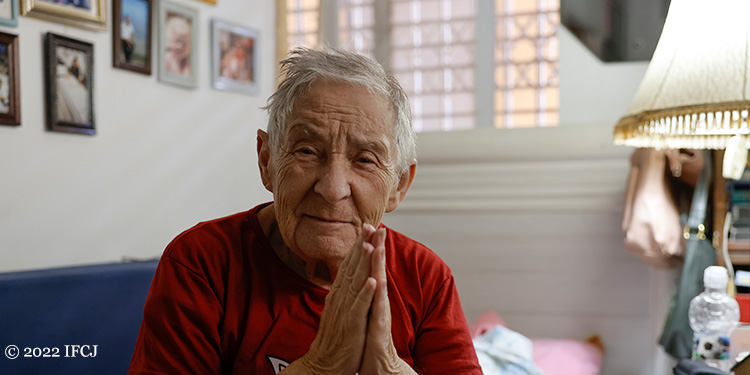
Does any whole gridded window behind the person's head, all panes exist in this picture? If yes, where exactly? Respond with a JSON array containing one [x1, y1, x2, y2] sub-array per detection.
[[286, 0, 560, 131]]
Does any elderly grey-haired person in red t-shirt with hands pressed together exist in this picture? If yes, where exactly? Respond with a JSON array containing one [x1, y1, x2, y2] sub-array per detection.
[[129, 49, 481, 375]]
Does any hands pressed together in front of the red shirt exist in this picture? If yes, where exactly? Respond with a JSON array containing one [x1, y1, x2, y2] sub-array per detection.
[[283, 224, 416, 375]]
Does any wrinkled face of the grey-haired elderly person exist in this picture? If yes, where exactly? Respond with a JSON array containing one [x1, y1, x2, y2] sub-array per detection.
[[264, 81, 400, 260]]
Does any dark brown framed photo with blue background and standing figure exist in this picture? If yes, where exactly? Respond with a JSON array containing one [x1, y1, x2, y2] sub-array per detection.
[[112, 0, 153, 75]]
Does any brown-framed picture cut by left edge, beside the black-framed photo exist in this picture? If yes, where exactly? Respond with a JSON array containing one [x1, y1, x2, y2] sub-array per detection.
[[0, 33, 21, 125]]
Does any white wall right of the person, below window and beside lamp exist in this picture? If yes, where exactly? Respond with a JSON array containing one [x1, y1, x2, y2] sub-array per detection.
[[384, 28, 676, 375]]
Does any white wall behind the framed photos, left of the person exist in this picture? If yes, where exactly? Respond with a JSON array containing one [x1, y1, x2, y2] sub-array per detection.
[[0, 0, 275, 271]]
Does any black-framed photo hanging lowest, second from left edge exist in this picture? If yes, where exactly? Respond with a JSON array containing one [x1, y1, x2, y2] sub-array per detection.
[[44, 33, 96, 134]]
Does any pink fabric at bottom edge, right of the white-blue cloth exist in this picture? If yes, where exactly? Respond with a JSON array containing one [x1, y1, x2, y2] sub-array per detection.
[[531, 339, 602, 375]]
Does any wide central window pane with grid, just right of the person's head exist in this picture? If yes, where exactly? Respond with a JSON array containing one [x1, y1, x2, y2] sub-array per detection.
[[390, 0, 475, 131]]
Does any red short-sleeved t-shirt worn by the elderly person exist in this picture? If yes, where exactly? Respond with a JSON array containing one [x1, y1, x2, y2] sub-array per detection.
[[128, 205, 482, 375]]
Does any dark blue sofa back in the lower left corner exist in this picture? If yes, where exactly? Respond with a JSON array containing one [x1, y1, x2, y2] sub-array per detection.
[[0, 261, 158, 375]]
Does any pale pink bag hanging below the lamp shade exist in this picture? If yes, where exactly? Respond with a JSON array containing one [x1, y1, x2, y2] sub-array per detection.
[[622, 148, 703, 268]]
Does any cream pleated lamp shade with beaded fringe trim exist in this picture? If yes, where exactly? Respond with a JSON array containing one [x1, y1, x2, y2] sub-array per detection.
[[614, 0, 750, 149]]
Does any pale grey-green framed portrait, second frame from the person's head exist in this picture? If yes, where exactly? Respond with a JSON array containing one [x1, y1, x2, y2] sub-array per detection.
[[159, 1, 198, 88]]
